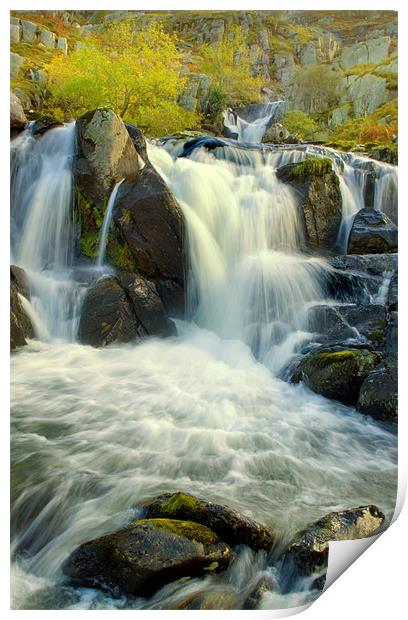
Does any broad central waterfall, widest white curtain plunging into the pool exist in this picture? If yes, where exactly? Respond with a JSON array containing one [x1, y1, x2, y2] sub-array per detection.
[[149, 145, 326, 371]]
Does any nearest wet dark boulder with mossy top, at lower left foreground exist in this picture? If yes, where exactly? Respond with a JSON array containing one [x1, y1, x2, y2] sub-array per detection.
[[63, 519, 231, 596]]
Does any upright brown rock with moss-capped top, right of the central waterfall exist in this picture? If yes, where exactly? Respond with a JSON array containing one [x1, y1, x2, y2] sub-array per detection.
[[277, 157, 342, 250]]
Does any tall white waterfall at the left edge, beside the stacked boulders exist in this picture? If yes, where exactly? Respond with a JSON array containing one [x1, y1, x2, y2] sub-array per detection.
[[11, 123, 82, 340]]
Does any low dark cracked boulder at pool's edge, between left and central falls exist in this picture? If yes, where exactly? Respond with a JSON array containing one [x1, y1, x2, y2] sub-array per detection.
[[79, 272, 176, 347]]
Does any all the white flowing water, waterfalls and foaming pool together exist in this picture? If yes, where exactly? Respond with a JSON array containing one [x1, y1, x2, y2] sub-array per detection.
[[11, 116, 397, 609]]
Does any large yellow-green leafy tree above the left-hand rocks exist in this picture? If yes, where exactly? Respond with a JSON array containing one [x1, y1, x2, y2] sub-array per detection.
[[47, 21, 199, 134]]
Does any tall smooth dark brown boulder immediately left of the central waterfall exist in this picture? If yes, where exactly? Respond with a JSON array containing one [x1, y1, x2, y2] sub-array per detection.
[[113, 166, 184, 286]]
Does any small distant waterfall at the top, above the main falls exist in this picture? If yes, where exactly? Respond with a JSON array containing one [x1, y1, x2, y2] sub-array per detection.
[[223, 101, 284, 143]]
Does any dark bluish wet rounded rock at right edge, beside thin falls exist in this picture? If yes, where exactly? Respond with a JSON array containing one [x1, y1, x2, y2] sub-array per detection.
[[347, 208, 398, 254]]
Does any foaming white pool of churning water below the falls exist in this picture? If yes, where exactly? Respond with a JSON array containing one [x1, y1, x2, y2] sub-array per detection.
[[12, 324, 396, 608]]
